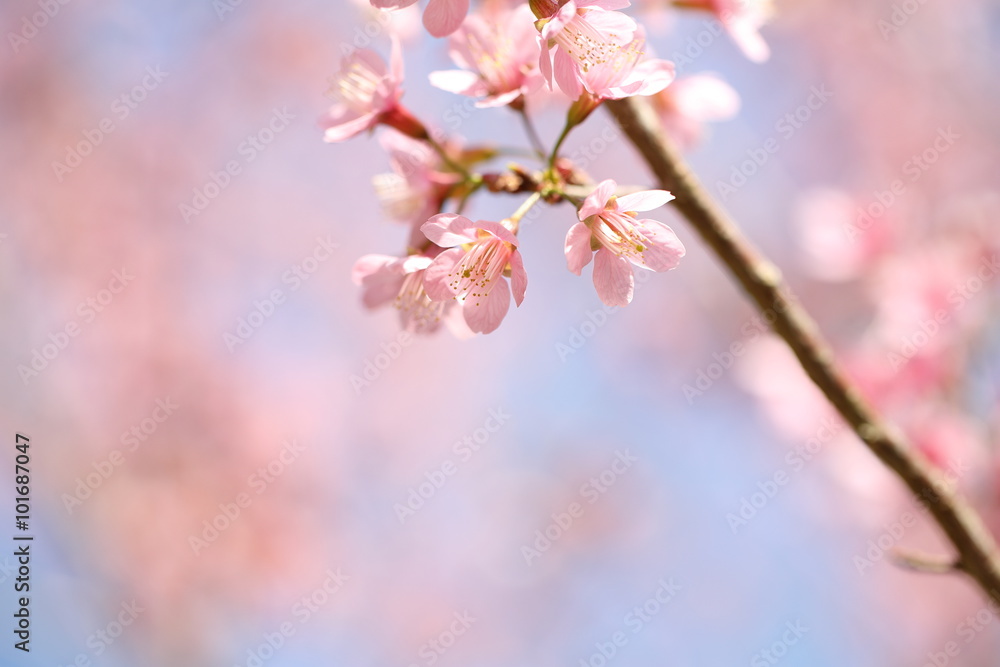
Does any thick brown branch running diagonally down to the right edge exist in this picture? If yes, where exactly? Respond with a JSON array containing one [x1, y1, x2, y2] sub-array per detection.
[[605, 98, 1000, 603]]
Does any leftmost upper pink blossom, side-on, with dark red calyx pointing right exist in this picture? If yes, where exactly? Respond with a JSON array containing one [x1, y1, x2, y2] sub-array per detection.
[[320, 39, 427, 142]]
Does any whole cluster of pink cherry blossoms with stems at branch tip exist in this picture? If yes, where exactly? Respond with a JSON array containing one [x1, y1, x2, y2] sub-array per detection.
[[321, 0, 768, 336]]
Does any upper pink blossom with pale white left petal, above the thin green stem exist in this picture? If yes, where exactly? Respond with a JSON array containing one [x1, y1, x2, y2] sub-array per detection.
[[430, 5, 542, 107]]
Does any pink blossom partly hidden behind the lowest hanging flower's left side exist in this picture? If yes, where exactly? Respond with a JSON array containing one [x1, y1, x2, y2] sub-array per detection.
[[351, 255, 464, 333]]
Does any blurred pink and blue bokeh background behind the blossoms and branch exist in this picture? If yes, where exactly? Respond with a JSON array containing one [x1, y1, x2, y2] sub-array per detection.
[[0, 0, 1000, 667]]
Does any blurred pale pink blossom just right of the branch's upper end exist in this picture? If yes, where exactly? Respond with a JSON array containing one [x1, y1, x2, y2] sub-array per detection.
[[652, 74, 740, 148]]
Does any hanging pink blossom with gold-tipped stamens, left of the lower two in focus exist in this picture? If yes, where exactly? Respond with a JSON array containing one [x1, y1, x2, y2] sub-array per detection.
[[421, 213, 528, 333]]
